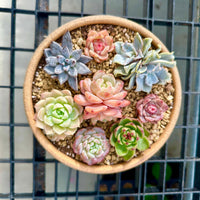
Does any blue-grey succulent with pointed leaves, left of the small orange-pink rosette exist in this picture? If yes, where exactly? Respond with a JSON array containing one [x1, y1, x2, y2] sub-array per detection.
[[44, 31, 92, 90]]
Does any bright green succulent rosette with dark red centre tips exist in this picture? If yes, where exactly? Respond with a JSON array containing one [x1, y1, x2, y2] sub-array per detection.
[[110, 118, 149, 161]]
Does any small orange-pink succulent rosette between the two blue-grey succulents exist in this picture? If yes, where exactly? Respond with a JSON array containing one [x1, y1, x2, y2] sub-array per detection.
[[85, 30, 115, 63]]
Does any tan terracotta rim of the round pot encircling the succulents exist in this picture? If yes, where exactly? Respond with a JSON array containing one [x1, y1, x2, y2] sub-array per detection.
[[24, 16, 181, 174]]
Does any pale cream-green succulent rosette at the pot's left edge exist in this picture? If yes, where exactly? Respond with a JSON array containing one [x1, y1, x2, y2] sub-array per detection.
[[35, 90, 83, 141]]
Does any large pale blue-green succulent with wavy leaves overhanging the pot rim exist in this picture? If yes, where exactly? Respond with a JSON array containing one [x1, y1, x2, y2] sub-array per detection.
[[113, 33, 176, 93]]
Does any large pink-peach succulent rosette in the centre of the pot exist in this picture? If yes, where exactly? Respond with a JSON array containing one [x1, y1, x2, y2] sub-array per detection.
[[74, 70, 130, 124]]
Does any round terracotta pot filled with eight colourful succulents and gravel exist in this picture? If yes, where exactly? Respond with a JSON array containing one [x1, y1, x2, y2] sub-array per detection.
[[24, 16, 181, 174]]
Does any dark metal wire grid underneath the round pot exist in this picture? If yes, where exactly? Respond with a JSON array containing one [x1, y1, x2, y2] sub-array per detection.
[[0, 0, 200, 200]]
